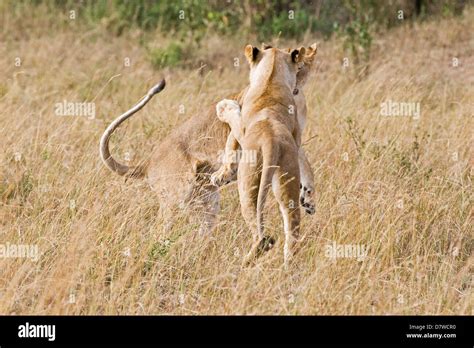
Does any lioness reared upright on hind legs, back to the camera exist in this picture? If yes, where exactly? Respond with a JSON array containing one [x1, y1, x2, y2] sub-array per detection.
[[217, 45, 305, 265]]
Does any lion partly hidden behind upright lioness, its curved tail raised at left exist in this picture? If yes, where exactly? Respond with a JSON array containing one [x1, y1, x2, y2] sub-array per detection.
[[100, 43, 316, 233]]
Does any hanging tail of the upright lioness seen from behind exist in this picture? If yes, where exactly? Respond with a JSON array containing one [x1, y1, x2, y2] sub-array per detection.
[[257, 140, 279, 236]]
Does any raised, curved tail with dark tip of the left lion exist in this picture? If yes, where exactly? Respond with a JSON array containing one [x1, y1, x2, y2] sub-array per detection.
[[99, 79, 166, 178]]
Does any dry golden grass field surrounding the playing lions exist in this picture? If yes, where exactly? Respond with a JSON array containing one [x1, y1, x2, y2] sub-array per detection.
[[0, 3, 474, 315]]
